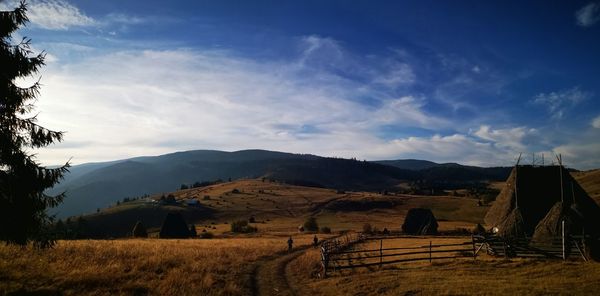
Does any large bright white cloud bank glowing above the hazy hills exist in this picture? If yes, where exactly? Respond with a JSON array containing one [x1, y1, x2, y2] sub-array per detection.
[[32, 50, 443, 163]]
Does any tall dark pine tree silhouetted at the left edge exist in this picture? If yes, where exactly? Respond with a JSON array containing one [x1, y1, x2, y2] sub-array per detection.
[[0, 1, 69, 248]]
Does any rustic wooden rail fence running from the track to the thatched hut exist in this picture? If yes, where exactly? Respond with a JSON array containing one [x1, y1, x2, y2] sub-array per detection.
[[321, 234, 587, 276]]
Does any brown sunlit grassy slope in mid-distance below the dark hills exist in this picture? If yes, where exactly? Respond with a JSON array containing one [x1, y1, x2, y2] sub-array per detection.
[[86, 179, 487, 234]]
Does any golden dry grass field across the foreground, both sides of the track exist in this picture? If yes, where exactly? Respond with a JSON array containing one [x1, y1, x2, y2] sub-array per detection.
[[0, 235, 600, 295]]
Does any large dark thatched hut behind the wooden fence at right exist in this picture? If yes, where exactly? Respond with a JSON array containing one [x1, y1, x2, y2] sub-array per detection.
[[485, 165, 600, 240]]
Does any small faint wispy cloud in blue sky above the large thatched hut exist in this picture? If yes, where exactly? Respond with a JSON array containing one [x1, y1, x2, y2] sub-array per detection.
[[532, 87, 591, 119]]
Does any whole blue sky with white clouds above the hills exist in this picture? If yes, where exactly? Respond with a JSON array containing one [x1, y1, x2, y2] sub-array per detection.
[[0, 0, 600, 169]]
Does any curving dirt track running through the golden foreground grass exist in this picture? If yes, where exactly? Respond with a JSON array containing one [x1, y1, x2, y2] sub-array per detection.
[[251, 245, 312, 296]]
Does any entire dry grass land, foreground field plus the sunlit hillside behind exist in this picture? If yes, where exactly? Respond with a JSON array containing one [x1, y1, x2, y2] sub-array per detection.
[[0, 174, 600, 295]]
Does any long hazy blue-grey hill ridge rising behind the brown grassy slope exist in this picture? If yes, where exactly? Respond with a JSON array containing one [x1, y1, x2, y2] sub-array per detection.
[[50, 150, 419, 217]]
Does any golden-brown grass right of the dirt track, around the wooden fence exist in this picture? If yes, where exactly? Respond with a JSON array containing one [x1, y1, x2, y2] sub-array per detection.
[[288, 237, 600, 295]]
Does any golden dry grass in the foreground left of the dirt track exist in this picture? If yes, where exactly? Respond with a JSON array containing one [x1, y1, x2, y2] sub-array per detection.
[[0, 235, 312, 295]]
